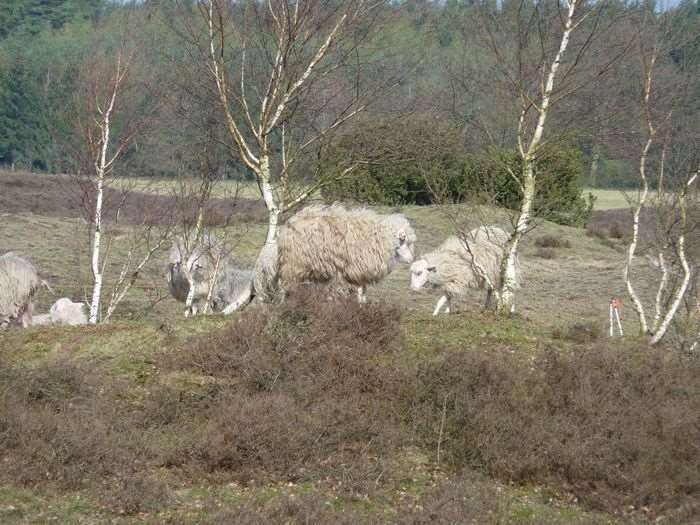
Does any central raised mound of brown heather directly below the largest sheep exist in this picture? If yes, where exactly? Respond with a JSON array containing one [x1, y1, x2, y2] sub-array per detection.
[[166, 293, 410, 481]]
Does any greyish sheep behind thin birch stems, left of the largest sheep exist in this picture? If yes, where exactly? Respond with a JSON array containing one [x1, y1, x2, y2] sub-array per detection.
[[167, 232, 253, 316]]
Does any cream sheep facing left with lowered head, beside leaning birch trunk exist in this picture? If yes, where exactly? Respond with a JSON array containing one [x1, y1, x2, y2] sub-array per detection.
[[411, 226, 520, 315]]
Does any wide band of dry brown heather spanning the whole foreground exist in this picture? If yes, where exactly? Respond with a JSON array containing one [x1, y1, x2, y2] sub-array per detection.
[[0, 290, 700, 523]]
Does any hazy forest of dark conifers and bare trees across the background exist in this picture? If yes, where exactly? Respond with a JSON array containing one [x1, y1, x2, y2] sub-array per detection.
[[0, 0, 700, 187]]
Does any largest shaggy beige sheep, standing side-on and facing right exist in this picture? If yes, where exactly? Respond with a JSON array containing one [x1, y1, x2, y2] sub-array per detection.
[[278, 204, 416, 303]]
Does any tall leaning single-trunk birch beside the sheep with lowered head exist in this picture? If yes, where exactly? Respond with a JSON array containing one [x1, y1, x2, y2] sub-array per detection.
[[462, 0, 621, 314]]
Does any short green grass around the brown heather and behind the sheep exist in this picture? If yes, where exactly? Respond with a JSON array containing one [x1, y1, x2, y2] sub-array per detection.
[[0, 171, 695, 524]]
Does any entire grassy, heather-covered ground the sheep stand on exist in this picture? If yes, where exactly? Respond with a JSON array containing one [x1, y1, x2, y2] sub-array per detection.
[[0, 170, 700, 524]]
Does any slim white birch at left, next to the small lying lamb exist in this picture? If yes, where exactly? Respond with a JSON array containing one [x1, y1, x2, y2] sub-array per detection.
[[65, 31, 170, 324]]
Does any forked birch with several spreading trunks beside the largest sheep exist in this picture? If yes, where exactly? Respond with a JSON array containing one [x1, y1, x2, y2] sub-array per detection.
[[178, 0, 381, 292]]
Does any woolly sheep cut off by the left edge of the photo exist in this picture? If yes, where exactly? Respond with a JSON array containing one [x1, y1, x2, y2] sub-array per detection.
[[0, 252, 50, 328]]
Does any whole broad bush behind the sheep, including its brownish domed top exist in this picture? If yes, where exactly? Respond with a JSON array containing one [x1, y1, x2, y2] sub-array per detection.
[[323, 118, 594, 226]]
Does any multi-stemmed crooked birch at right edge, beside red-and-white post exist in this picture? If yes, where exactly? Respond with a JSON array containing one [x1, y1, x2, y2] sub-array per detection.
[[623, 8, 700, 344]]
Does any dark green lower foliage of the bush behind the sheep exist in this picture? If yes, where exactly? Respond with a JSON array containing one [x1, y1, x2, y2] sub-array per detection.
[[323, 135, 593, 226]]
